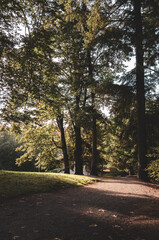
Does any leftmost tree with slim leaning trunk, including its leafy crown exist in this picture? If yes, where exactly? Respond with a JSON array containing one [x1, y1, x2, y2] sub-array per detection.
[[0, 1, 69, 173]]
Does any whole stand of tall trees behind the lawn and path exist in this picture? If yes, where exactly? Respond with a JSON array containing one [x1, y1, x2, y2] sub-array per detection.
[[0, 0, 159, 181]]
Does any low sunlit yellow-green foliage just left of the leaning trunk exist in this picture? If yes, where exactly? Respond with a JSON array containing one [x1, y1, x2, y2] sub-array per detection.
[[16, 123, 63, 171]]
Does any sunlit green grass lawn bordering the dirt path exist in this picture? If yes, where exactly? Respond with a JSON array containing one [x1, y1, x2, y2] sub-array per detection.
[[0, 171, 98, 199]]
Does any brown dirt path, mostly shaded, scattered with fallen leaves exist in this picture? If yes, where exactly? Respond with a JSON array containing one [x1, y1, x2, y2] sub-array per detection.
[[0, 177, 159, 240]]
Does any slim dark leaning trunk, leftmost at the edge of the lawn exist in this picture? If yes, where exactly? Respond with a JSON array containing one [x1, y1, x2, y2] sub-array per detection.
[[57, 116, 70, 173]]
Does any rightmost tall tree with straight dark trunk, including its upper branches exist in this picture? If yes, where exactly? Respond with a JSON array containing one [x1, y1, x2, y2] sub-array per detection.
[[102, 0, 158, 180]]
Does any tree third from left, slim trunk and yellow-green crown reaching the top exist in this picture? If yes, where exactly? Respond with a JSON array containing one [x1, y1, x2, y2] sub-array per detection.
[[61, 1, 129, 175]]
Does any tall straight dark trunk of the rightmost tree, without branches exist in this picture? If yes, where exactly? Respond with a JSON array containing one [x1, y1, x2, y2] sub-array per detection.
[[134, 0, 147, 180]]
